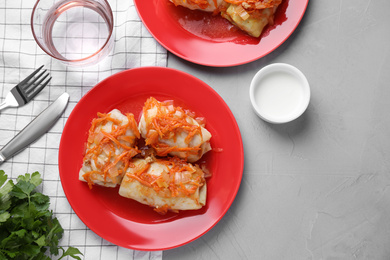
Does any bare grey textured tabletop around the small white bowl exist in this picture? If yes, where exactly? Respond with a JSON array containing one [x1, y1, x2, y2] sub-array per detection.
[[163, 0, 390, 259]]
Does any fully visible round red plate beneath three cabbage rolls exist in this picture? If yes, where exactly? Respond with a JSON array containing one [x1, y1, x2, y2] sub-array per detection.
[[59, 67, 244, 251]]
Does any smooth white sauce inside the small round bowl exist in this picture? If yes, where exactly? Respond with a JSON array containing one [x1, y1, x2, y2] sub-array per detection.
[[254, 71, 304, 118]]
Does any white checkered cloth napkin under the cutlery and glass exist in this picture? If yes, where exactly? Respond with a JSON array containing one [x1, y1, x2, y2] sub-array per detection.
[[0, 0, 167, 260]]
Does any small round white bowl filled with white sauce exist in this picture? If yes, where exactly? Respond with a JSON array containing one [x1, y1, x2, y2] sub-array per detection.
[[249, 63, 310, 124]]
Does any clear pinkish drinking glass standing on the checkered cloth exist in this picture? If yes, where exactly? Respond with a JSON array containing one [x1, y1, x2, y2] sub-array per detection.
[[31, 0, 114, 66]]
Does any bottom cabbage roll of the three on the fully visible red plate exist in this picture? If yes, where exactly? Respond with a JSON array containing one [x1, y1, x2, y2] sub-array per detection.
[[119, 157, 207, 214]]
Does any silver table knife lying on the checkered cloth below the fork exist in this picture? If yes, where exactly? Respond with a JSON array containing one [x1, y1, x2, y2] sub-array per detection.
[[0, 93, 69, 164]]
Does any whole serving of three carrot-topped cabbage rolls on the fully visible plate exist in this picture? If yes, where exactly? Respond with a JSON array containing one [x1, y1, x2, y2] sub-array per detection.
[[79, 97, 211, 214]]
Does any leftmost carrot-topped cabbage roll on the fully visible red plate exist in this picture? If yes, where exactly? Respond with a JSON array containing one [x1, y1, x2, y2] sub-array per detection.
[[79, 109, 140, 188]]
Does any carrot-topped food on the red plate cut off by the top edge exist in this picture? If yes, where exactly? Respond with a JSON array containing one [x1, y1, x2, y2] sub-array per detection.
[[170, 0, 282, 37]]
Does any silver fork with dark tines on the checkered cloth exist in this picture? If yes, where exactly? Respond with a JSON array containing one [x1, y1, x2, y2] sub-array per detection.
[[0, 65, 51, 111]]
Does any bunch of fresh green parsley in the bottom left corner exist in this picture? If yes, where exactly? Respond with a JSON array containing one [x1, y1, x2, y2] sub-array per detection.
[[0, 170, 82, 260]]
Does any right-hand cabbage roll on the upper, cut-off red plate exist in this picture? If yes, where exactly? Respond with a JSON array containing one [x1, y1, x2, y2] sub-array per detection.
[[221, 0, 282, 37]]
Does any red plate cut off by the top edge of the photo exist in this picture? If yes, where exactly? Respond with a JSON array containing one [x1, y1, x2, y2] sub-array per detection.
[[134, 0, 309, 67]]
